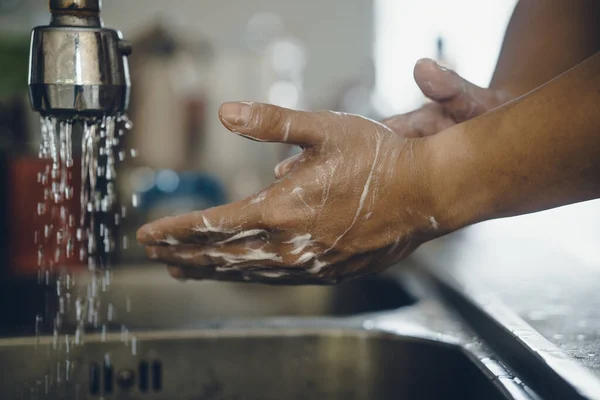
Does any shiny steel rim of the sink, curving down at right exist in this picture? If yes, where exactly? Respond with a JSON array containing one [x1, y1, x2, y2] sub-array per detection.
[[0, 301, 533, 399]]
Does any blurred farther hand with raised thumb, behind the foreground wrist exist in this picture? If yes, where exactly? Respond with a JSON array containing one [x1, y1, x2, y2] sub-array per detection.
[[383, 59, 512, 138]]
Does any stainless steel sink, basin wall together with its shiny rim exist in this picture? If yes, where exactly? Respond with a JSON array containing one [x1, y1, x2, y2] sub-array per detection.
[[0, 282, 536, 400]]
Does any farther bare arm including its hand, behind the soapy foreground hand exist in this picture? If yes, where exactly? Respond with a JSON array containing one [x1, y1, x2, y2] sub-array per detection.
[[384, 0, 600, 138]]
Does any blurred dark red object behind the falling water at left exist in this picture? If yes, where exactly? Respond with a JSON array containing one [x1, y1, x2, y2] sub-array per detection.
[[5, 156, 84, 278]]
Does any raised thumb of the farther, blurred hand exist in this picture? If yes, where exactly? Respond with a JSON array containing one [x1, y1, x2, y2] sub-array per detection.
[[414, 58, 496, 123]]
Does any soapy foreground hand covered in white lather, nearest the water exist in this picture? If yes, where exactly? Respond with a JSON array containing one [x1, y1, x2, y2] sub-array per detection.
[[138, 103, 445, 284]]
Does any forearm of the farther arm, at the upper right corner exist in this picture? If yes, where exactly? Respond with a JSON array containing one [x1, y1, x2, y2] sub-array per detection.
[[490, 0, 600, 98]]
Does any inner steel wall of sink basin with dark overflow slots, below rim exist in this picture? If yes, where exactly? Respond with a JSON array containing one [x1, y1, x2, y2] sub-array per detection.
[[0, 328, 509, 400]]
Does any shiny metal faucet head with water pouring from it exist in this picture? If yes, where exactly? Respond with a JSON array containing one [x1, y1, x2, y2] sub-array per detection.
[[29, 0, 132, 120]]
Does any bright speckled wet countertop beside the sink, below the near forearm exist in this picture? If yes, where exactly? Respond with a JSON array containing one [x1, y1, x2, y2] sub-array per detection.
[[415, 228, 600, 377]]
